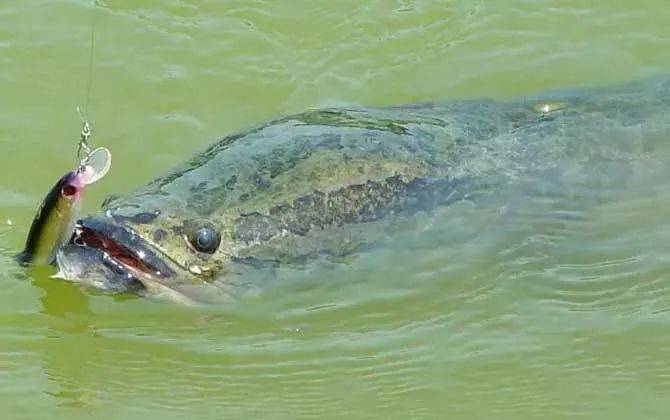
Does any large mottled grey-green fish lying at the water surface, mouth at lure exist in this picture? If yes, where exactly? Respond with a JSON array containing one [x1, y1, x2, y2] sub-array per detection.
[[53, 79, 670, 300]]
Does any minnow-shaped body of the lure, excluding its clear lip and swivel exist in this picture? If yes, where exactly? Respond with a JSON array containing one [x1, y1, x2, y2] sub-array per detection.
[[17, 171, 86, 265]]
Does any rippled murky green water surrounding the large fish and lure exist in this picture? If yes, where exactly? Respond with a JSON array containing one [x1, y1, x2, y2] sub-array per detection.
[[0, 0, 670, 419]]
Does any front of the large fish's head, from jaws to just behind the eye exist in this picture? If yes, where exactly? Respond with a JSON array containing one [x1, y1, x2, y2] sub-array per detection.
[[57, 195, 238, 303]]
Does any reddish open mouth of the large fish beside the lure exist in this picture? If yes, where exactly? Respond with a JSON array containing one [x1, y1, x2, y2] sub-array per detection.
[[59, 217, 175, 284]]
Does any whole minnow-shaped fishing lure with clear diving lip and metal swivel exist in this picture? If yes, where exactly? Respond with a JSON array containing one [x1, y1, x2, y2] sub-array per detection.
[[18, 121, 112, 265]]
